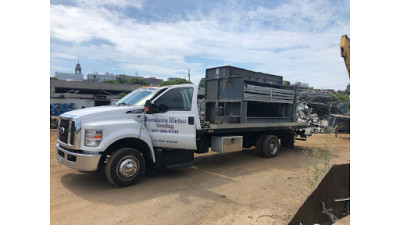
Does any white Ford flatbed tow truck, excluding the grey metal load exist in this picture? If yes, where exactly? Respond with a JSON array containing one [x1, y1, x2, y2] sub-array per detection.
[[56, 66, 307, 187]]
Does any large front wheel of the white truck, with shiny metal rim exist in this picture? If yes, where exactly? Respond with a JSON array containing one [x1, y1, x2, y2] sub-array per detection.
[[104, 148, 146, 187]]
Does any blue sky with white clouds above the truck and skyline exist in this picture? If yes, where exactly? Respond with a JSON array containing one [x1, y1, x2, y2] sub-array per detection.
[[50, 0, 351, 90]]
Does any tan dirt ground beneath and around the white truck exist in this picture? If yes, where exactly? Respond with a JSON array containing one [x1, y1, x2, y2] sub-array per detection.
[[50, 131, 350, 224]]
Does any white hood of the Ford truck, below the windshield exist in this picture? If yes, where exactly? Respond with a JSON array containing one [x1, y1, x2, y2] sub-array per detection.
[[60, 106, 144, 123]]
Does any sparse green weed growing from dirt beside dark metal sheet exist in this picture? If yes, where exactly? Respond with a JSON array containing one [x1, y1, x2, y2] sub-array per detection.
[[303, 135, 333, 187]]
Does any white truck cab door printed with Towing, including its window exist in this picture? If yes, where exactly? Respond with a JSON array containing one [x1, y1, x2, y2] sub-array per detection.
[[145, 87, 197, 150]]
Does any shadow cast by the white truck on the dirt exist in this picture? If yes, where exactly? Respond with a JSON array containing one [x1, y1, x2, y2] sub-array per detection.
[[61, 147, 305, 205]]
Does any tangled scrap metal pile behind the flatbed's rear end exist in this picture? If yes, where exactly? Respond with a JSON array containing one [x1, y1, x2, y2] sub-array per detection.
[[296, 92, 350, 135]]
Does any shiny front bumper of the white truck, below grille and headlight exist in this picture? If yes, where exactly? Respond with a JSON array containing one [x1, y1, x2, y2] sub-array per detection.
[[56, 144, 101, 171]]
